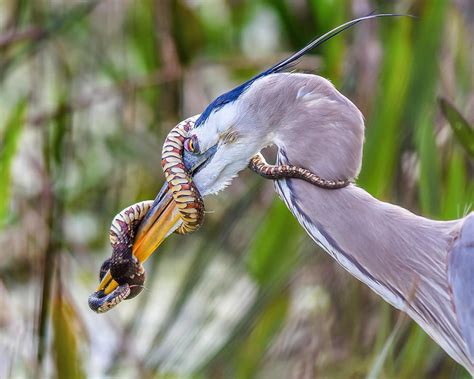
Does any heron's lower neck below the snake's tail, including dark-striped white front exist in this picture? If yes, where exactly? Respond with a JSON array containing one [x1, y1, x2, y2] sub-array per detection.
[[276, 163, 468, 368]]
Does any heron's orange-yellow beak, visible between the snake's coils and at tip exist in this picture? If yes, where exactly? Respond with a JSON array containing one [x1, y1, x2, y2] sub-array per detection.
[[97, 183, 181, 295]]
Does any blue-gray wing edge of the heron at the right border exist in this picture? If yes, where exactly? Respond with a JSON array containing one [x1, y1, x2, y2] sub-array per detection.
[[448, 213, 474, 360]]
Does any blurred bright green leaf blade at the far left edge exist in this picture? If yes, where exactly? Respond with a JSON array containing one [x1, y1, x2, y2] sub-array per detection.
[[0, 100, 27, 227]]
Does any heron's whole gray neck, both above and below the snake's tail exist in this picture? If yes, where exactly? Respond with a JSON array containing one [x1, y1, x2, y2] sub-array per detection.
[[243, 74, 468, 368]]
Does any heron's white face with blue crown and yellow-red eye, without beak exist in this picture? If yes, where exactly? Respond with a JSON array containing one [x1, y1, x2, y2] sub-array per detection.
[[184, 79, 271, 196]]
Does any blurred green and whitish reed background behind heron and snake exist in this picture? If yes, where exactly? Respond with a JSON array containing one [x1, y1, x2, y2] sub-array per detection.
[[0, 0, 474, 379]]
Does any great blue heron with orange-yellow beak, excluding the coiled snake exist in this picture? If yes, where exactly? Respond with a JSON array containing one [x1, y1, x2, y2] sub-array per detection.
[[94, 14, 474, 374]]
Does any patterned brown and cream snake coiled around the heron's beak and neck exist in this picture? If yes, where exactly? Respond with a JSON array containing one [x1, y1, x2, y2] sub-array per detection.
[[89, 117, 350, 313]]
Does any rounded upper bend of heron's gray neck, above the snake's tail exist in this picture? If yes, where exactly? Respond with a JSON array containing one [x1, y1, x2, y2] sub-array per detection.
[[239, 74, 364, 180]]
